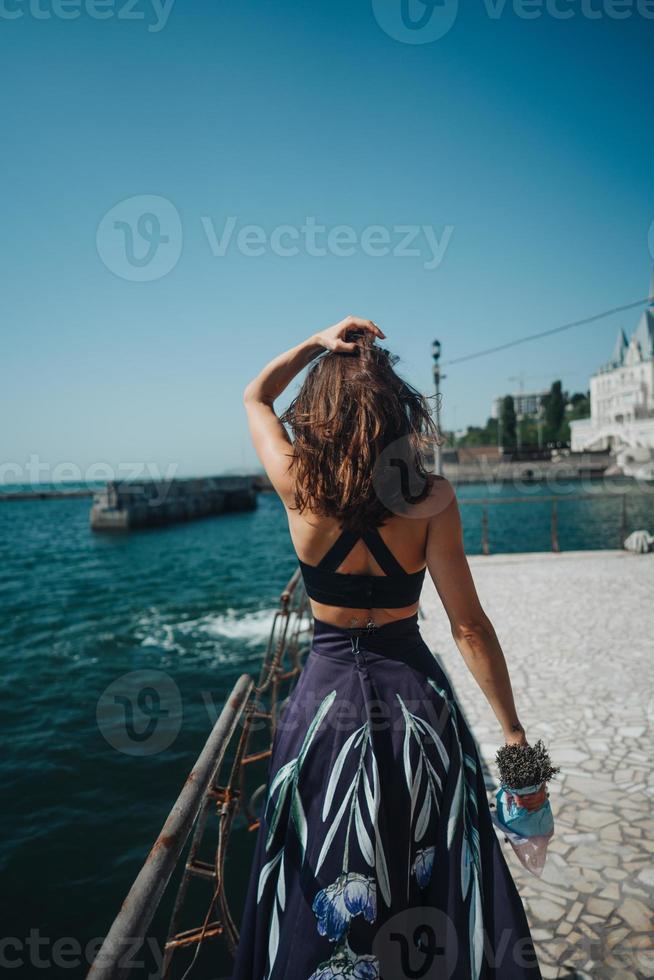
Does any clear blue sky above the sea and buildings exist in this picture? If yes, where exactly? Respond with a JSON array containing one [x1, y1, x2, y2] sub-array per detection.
[[0, 0, 654, 479]]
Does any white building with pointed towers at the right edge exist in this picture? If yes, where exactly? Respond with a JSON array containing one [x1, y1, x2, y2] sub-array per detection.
[[570, 283, 654, 472]]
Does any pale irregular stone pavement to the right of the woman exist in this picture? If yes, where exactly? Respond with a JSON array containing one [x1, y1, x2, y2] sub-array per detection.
[[421, 551, 654, 980]]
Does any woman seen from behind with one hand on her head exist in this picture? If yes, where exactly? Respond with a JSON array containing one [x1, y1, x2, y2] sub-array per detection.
[[233, 316, 544, 980]]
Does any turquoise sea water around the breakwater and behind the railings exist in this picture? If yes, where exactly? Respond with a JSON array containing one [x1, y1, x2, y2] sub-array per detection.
[[0, 487, 654, 977]]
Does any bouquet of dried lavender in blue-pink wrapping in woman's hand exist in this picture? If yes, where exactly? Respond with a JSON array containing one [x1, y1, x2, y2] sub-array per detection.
[[492, 739, 560, 876]]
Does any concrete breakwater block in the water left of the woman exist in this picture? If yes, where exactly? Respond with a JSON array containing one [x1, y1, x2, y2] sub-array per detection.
[[90, 476, 257, 531]]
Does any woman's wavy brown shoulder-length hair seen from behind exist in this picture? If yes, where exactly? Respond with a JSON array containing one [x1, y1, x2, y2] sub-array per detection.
[[281, 331, 440, 530]]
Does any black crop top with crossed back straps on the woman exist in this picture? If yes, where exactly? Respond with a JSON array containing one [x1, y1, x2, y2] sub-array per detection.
[[298, 528, 426, 609]]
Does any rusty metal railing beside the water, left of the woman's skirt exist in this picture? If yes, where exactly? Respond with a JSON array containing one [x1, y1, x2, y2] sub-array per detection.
[[88, 569, 312, 980]]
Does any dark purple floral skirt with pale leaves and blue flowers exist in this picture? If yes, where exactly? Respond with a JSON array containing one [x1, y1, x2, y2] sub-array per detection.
[[233, 616, 541, 980]]
